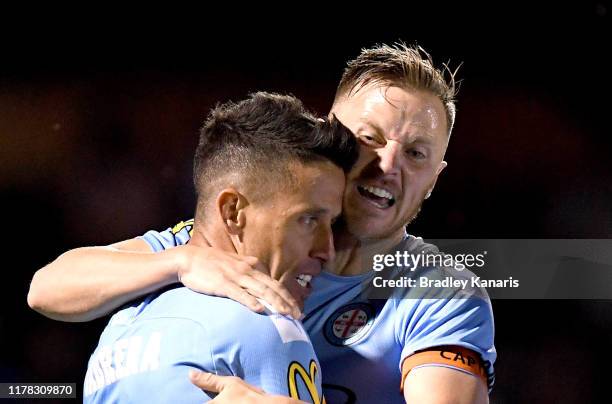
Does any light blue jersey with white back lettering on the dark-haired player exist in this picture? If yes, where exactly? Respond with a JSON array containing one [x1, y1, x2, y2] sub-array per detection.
[[84, 251, 323, 404]]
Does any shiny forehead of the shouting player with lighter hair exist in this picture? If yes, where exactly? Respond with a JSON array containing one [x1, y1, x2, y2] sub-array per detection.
[[332, 86, 447, 142]]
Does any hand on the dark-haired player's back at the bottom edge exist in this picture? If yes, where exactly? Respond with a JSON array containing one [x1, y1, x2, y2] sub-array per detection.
[[189, 370, 304, 404]]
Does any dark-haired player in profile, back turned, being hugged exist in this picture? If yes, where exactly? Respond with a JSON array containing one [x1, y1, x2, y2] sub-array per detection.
[[84, 93, 358, 404]]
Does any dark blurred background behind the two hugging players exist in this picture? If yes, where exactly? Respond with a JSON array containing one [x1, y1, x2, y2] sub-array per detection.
[[0, 2, 612, 403]]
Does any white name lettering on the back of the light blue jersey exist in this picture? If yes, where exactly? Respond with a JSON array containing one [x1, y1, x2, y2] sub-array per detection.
[[84, 332, 162, 396]]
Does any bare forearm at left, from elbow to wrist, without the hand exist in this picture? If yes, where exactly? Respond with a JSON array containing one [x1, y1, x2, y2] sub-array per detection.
[[28, 240, 178, 321]]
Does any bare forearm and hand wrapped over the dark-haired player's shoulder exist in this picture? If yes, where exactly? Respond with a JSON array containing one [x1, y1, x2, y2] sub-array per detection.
[[28, 234, 301, 321]]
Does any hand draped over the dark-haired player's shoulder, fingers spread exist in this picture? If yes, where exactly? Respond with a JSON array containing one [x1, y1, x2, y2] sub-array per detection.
[[172, 244, 302, 319]]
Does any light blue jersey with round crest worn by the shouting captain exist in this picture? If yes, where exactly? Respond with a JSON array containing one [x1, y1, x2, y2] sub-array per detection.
[[131, 222, 496, 403]]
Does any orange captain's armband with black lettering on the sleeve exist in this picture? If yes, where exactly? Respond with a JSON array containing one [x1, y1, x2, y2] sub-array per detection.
[[400, 346, 488, 392]]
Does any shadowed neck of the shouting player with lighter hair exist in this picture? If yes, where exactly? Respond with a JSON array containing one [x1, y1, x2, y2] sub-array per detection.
[[326, 224, 404, 276]]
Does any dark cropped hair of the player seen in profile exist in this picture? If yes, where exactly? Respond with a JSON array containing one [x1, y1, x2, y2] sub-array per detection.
[[193, 92, 359, 210]]
